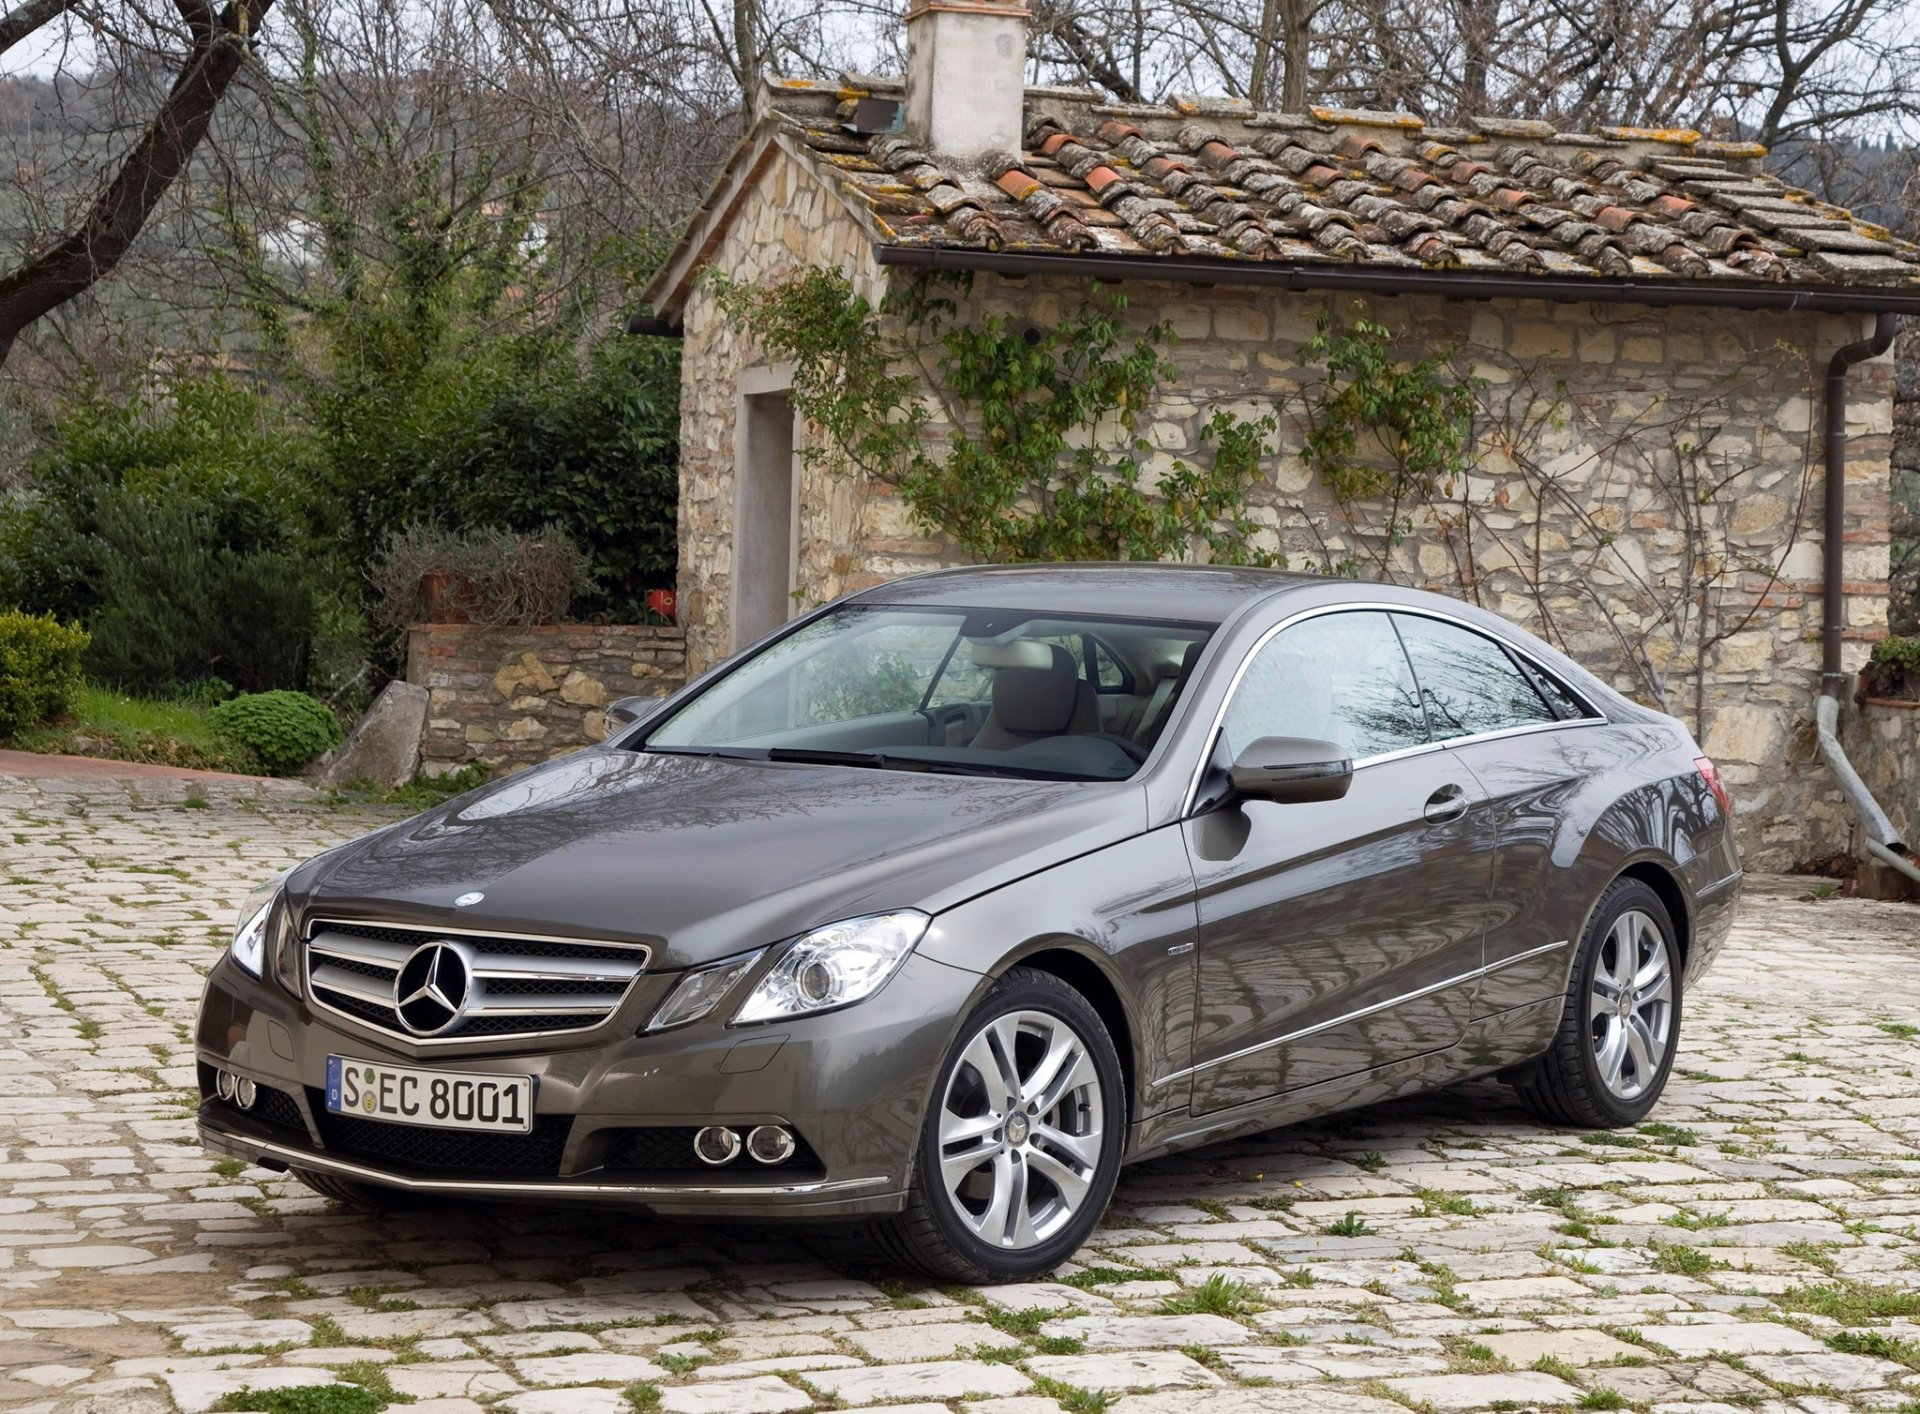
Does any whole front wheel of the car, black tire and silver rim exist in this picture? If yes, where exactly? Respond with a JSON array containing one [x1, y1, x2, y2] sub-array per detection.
[[874, 966, 1127, 1283]]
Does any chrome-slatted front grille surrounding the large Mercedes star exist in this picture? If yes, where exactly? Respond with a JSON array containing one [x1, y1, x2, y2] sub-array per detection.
[[305, 922, 649, 1041]]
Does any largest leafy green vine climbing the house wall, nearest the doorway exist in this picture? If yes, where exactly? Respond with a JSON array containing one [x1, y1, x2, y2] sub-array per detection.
[[710, 269, 1284, 565]]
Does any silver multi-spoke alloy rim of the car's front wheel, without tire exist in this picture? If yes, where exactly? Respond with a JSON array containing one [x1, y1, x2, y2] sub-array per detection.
[[939, 1011, 1106, 1251]]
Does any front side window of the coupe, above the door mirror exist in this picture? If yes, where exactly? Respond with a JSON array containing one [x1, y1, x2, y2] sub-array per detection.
[[1221, 611, 1427, 761]]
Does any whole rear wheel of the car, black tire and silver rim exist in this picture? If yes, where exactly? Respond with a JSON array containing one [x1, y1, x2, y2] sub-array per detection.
[[1513, 878, 1682, 1130]]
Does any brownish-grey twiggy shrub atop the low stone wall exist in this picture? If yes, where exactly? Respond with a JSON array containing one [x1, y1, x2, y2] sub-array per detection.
[[369, 524, 591, 628]]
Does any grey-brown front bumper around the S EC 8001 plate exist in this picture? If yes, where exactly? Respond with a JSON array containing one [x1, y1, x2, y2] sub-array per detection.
[[194, 955, 987, 1220]]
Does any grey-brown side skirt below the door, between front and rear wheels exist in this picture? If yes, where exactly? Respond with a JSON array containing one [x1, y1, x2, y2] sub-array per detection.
[[1127, 997, 1565, 1164]]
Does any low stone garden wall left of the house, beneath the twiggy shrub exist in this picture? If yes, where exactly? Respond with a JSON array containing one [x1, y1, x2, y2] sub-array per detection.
[[407, 624, 687, 776]]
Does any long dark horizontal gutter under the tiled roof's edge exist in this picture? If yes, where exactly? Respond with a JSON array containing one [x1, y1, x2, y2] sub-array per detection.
[[874, 244, 1920, 315]]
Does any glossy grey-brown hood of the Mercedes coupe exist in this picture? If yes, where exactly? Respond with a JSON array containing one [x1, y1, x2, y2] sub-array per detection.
[[288, 747, 1146, 968]]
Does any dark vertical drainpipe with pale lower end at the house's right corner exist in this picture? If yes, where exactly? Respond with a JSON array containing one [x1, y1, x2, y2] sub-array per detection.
[[1814, 313, 1920, 884]]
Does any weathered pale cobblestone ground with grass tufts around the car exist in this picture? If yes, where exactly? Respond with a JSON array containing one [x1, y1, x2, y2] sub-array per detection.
[[0, 780, 1920, 1414]]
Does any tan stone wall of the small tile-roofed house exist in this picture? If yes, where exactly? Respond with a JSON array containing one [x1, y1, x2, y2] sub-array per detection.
[[680, 163, 1893, 868]]
